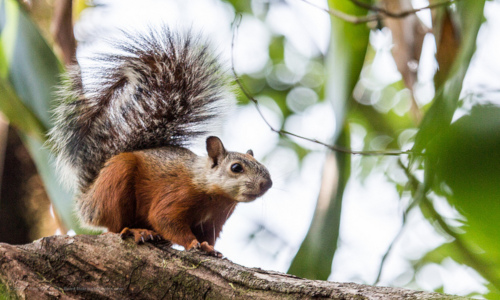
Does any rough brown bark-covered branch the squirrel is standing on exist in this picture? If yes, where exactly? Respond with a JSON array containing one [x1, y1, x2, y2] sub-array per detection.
[[0, 234, 460, 299]]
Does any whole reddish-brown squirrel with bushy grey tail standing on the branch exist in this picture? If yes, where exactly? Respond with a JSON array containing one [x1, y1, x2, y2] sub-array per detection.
[[48, 27, 272, 257]]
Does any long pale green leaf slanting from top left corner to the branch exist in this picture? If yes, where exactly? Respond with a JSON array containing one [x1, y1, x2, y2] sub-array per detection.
[[0, 0, 85, 232]]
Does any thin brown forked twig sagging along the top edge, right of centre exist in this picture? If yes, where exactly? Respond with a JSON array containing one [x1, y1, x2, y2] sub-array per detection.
[[301, 0, 458, 24]]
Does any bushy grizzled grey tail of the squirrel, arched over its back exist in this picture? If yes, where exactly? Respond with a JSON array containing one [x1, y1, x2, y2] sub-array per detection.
[[49, 27, 230, 190]]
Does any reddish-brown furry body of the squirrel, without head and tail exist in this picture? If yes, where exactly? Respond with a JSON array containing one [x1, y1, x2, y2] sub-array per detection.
[[84, 152, 237, 252]]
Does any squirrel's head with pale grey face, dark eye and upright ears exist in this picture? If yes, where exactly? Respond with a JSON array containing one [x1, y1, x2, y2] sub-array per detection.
[[207, 136, 273, 202]]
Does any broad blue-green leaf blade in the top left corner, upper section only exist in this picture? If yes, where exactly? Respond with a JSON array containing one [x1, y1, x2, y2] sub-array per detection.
[[0, 0, 63, 128]]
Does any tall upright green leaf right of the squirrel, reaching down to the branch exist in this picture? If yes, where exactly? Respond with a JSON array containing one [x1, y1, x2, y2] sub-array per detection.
[[288, 0, 370, 280]]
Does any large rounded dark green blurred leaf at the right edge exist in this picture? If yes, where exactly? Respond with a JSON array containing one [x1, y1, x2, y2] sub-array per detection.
[[426, 105, 500, 296]]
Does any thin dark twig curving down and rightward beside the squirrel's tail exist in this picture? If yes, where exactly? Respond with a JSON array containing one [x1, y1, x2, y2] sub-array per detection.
[[231, 16, 413, 156]]
